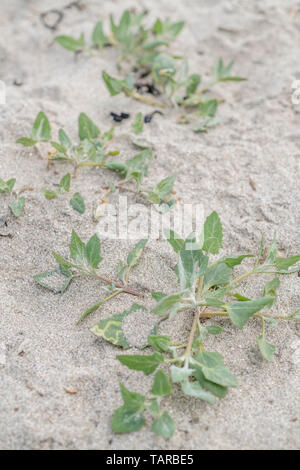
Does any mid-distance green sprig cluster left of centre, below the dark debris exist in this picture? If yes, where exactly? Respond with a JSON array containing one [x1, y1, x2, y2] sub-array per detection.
[[17, 112, 175, 219]]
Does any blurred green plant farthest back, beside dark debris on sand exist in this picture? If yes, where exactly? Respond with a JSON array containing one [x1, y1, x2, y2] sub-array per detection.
[[56, 10, 245, 132]]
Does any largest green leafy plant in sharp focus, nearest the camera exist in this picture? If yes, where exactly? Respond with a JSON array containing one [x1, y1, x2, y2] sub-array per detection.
[[92, 212, 300, 437]]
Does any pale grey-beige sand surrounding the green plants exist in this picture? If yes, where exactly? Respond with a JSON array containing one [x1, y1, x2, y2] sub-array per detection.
[[0, 0, 300, 449]]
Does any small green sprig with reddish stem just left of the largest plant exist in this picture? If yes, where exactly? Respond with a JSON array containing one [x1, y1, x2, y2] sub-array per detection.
[[34, 230, 147, 323]]
